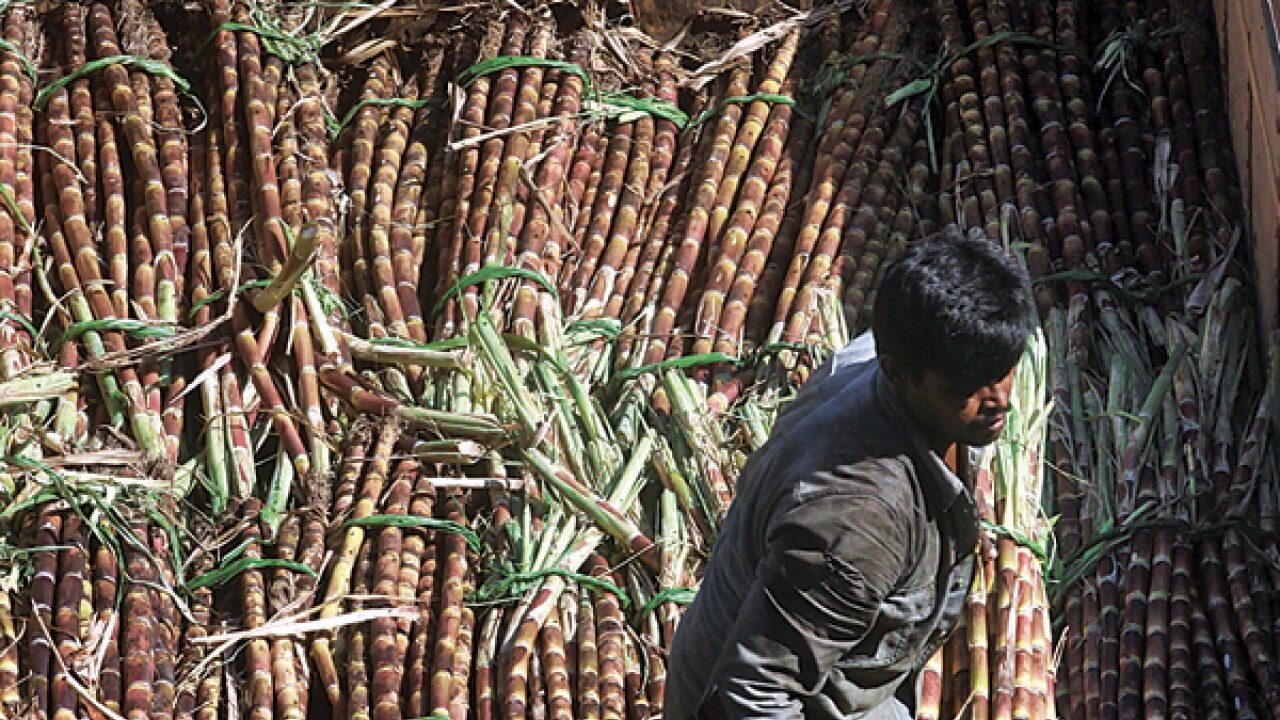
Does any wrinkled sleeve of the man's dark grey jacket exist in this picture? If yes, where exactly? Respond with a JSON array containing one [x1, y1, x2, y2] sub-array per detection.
[[709, 478, 909, 719]]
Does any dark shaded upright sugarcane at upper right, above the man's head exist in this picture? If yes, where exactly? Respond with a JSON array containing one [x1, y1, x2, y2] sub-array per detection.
[[931, 1, 1238, 299]]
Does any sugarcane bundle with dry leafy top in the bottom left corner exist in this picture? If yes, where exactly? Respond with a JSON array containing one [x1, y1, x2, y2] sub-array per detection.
[[0, 451, 212, 717]]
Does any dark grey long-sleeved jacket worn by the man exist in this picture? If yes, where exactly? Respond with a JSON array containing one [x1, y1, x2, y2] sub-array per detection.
[[664, 333, 978, 720]]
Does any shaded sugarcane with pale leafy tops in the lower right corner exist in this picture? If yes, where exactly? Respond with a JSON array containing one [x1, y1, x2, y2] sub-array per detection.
[[1055, 278, 1275, 717]]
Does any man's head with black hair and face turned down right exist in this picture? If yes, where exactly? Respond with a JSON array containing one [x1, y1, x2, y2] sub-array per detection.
[[872, 230, 1034, 451]]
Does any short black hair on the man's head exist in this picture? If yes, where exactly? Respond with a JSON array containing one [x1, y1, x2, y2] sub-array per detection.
[[872, 234, 1034, 388]]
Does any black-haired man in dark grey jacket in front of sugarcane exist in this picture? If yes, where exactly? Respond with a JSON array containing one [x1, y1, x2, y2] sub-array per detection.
[[664, 237, 1033, 720]]
